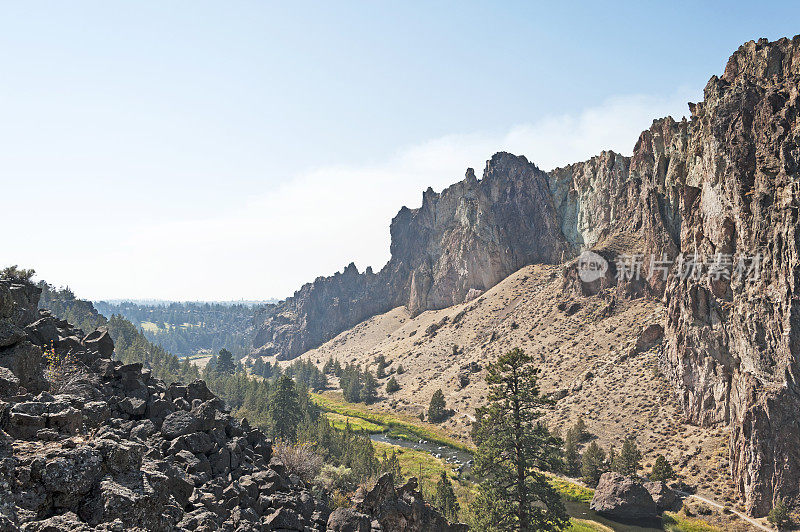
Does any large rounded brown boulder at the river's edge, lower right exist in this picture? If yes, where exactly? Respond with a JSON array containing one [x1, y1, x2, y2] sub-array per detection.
[[589, 472, 658, 520]]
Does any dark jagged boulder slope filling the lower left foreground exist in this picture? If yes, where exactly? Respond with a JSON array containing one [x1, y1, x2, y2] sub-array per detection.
[[0, 280, 461, 532]]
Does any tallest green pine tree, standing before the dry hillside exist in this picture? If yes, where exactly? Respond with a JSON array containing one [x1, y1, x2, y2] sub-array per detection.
[[472, 348, 569, 532]]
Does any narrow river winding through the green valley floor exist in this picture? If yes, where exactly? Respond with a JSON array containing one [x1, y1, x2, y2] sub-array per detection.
[[372, 432, 664, 532]]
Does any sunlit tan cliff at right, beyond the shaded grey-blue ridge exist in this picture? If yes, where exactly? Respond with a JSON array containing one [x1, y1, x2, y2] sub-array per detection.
[[551, 37, 800, 515]]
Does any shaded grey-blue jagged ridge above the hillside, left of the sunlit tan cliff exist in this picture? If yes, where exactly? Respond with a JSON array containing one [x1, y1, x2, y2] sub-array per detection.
[[254, 153, 571, 359]]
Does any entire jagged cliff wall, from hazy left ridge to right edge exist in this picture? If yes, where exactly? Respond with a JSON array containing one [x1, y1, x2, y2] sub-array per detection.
[[254, 36, 800, 516]]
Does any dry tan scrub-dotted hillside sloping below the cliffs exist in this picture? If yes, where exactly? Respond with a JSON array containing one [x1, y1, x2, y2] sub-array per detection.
[[286, 265, 732, 508]]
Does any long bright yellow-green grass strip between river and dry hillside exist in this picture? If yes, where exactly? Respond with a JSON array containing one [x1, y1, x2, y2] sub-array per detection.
[[311, 393, 475, 452]]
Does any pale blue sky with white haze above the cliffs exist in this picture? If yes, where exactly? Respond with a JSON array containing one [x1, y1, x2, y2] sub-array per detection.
[[0, 0, 800, 300]]
